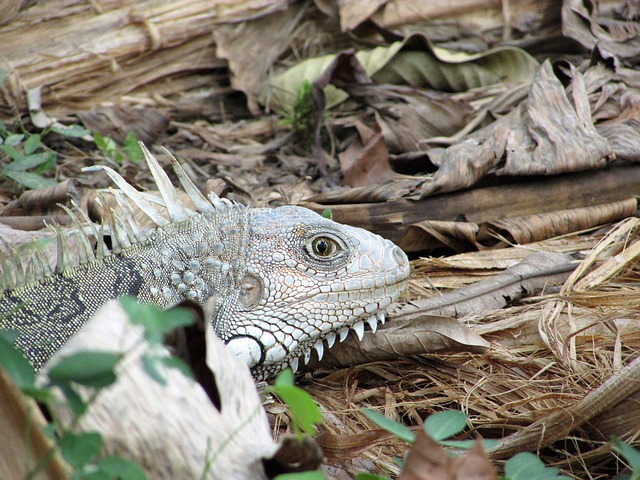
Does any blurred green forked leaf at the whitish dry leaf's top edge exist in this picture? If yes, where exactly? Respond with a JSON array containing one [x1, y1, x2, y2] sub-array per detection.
[[120, 297, 193, 344]]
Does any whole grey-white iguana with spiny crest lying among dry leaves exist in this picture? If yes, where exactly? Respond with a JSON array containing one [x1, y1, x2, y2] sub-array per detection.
[[0, 145, 409, 379]]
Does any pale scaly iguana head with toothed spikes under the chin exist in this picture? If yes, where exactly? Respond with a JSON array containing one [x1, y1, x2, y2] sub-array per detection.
[[213, 207, 409, 378]]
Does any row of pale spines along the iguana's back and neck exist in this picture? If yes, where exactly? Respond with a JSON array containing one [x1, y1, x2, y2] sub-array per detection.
[[0, 143, 235, 297]]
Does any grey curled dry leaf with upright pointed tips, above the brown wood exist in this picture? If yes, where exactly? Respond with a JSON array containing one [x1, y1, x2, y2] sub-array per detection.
[[421, 61, 613, 197]]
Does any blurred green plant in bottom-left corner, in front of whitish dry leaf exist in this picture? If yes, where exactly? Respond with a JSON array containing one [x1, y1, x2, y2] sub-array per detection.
[[0, 298, 193, 480]]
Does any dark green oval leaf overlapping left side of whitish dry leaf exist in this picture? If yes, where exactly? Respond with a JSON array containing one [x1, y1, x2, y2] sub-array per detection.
[[49, 352, 122, 388]]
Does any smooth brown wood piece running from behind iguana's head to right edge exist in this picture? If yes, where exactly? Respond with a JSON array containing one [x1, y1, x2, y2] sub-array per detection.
[[302, 165, 640, 248]]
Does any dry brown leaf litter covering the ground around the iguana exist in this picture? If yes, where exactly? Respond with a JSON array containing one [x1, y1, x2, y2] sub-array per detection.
[[0, 0, 640, 478]]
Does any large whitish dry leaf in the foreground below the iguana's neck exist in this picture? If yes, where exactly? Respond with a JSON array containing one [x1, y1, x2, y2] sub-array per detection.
[[41, 301, 277, 479]]
